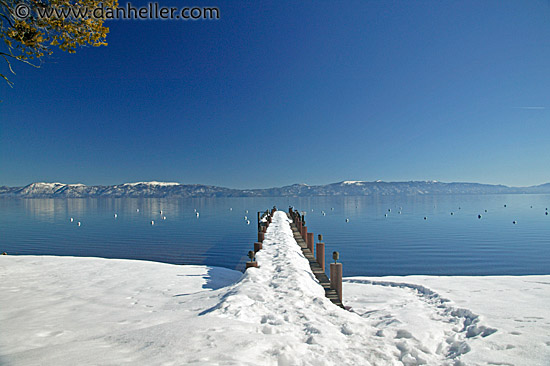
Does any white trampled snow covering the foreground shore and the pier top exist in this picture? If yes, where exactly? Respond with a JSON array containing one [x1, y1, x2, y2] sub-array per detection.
[[0, 212, 550, 365]]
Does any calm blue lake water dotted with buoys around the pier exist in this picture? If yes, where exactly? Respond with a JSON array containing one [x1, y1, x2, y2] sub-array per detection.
[[0, 195, 550, 276]]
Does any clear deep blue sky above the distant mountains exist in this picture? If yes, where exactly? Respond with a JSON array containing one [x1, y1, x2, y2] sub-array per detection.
[[0, 0, 550, 188]]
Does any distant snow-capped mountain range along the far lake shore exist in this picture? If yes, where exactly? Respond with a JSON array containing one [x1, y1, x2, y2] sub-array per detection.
[[0, 181, 550, 198]]
